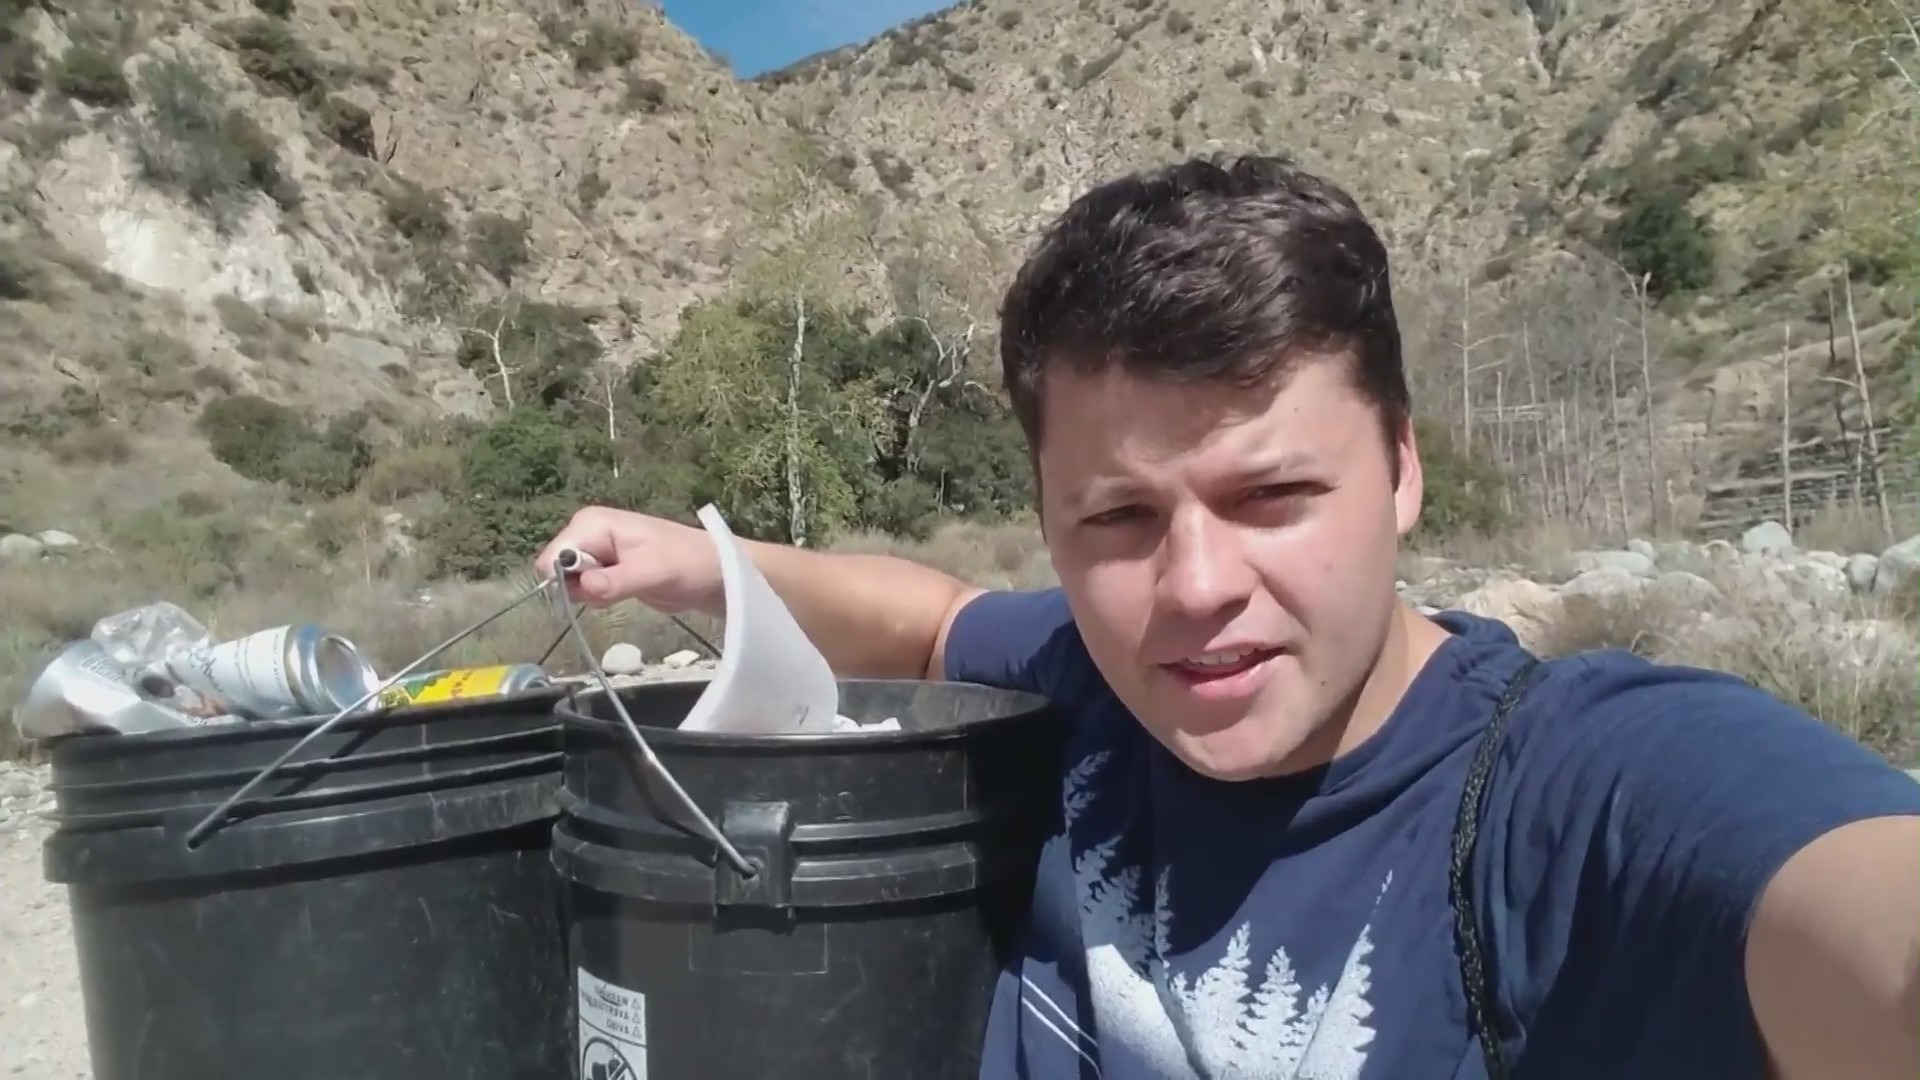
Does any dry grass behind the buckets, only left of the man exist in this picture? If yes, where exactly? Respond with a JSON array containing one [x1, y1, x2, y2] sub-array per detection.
[[0, 496, 1052, 757]]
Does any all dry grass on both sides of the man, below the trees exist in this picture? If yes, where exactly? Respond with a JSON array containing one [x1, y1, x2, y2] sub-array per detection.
[[0, 496, 1920, 763]]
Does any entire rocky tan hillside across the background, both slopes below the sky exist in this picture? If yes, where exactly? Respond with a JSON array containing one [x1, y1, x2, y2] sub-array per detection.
[[0, 0, 1916, 530]]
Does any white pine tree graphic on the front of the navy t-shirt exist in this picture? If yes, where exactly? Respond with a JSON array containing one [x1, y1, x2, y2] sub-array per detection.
[[1044, 751, 1390, 1080]]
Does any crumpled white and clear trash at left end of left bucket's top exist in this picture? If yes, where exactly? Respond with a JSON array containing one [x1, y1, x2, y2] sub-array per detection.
[[13, 638, 207, 738]]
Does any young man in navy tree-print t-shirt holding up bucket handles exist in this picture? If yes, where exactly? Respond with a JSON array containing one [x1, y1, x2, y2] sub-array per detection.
[[541, 158, 1920, 1080]]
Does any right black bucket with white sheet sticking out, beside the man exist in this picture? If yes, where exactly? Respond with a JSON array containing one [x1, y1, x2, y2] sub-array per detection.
[[553, 680, 1064, 1080]]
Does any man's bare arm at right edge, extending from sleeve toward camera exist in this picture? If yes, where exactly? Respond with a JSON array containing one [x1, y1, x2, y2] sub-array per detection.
[[1747, 817, 1920, 1080]]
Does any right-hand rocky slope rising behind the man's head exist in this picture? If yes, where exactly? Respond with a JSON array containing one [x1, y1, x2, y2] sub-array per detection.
[[764, 0, 1920, 518]]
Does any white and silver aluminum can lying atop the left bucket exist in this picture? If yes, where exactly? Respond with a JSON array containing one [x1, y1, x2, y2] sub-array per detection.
[[161, 623, 380, 721]]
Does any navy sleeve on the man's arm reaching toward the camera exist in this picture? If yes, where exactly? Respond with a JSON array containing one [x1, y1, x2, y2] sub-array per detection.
[[1486, 653, 1920, 1076]]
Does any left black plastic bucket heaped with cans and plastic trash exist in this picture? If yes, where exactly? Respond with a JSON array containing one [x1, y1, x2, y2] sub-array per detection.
[[44, 688, 572, 1080]]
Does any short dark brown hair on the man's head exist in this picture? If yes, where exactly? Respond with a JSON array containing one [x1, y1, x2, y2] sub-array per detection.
[[1000, 156, 1409, 452]]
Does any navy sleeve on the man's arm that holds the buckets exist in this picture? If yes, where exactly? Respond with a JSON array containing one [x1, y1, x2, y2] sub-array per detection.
[[941, 588, 1092, 701]]
